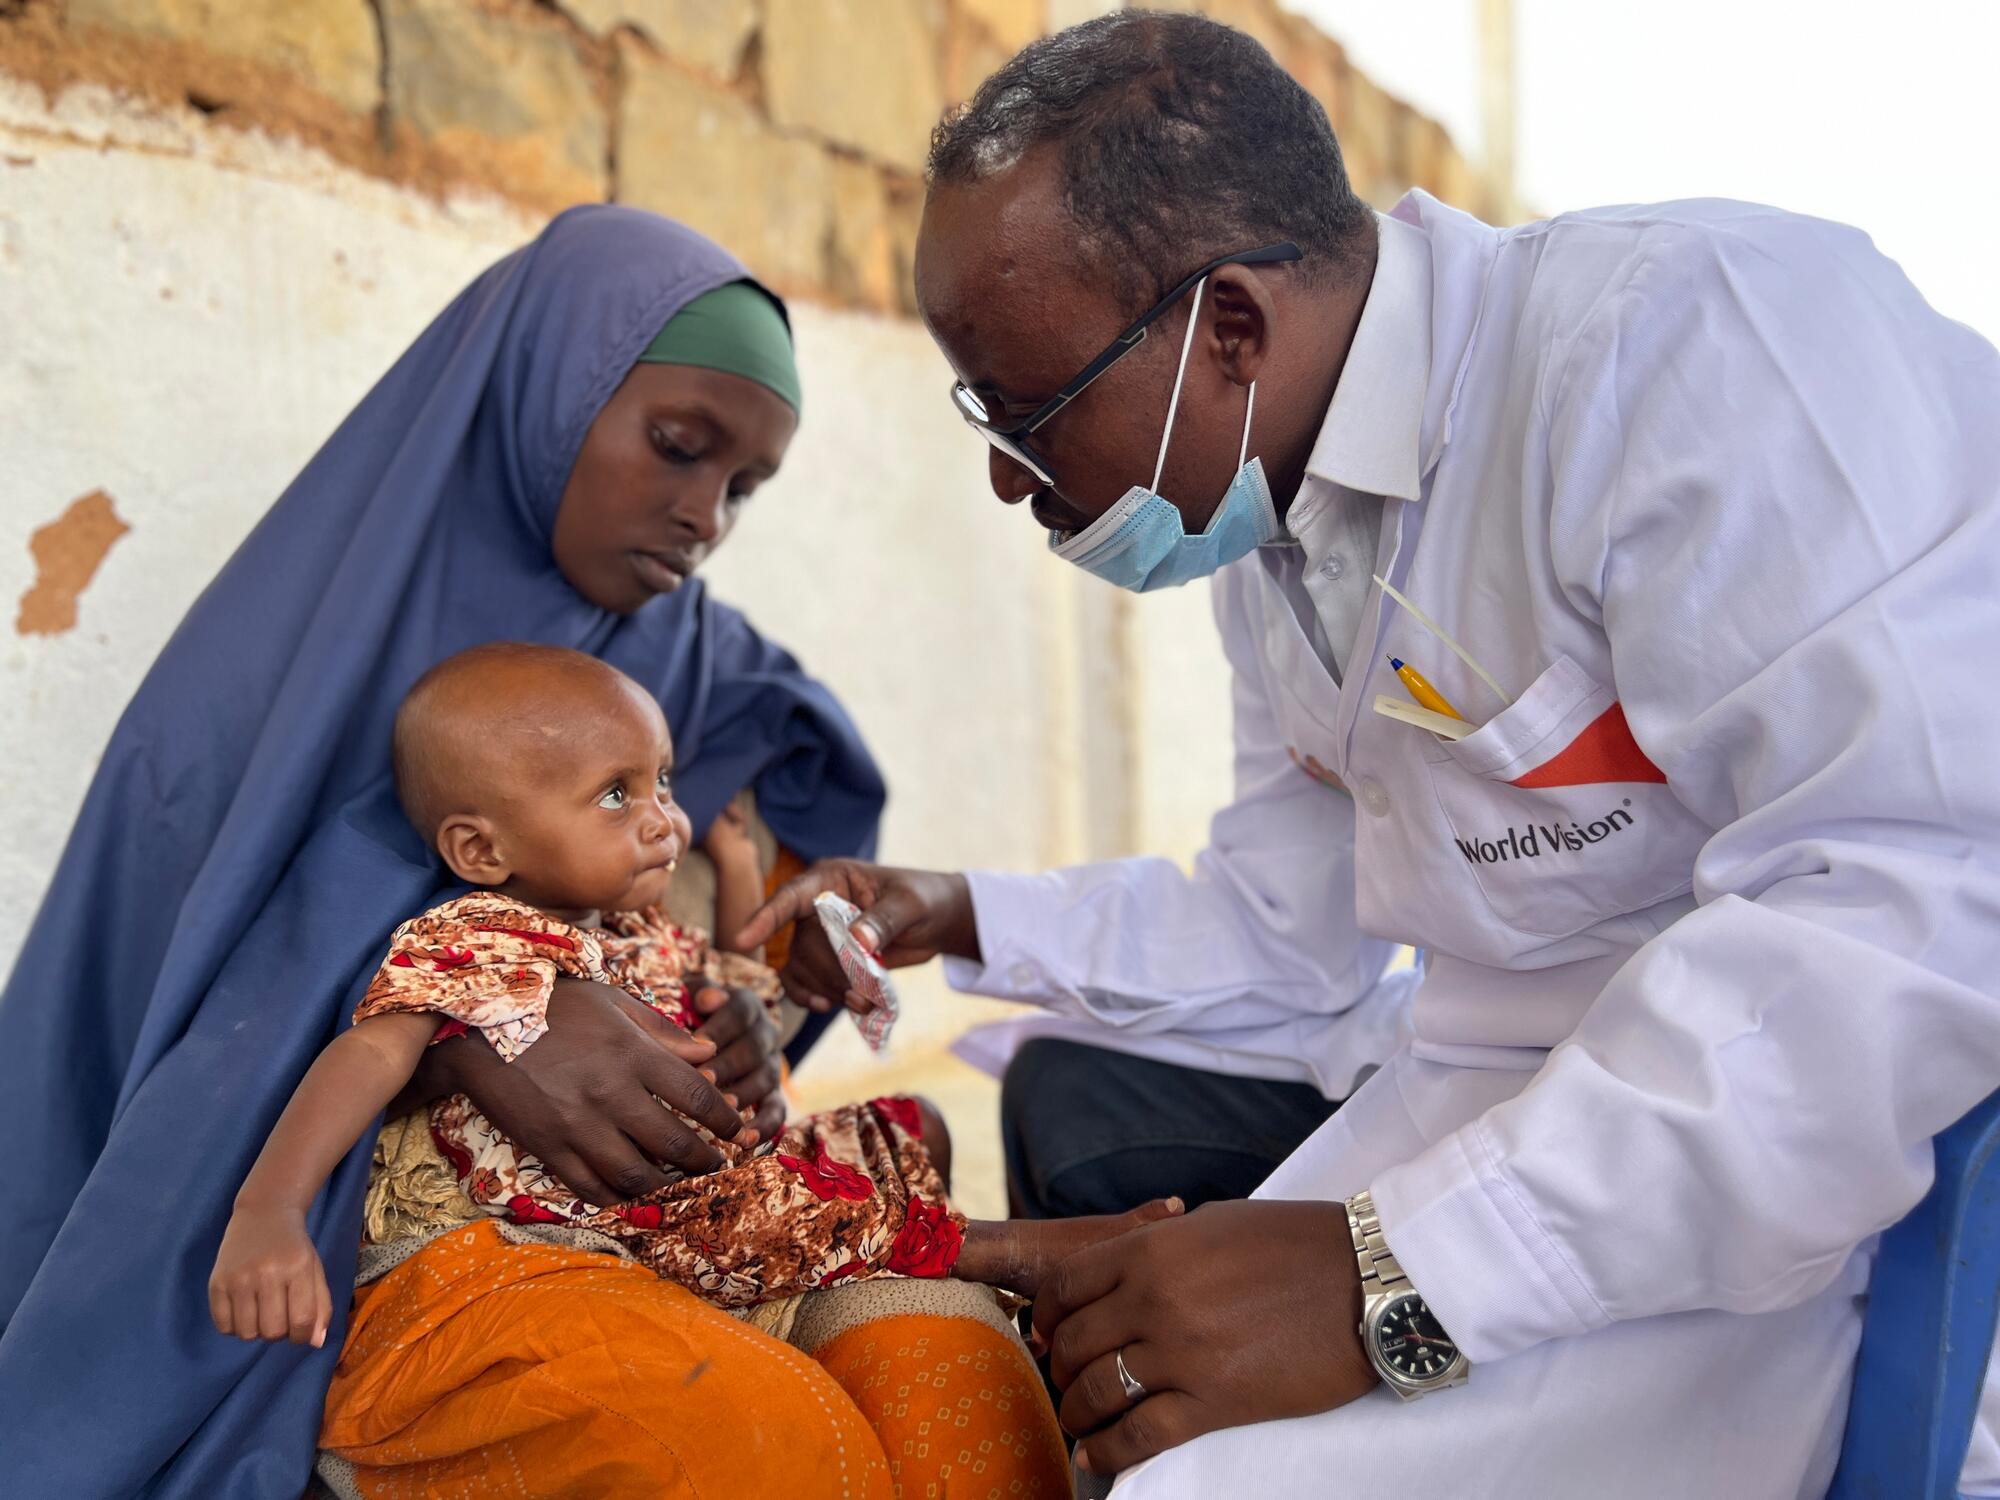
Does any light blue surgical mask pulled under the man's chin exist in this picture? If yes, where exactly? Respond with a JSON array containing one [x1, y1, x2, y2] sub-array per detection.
[[1048, 278, 1278, 594]]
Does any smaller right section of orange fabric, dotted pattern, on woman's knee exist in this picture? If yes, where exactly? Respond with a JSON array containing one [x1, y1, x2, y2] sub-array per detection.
[[812, 1316, 1070, 1500]]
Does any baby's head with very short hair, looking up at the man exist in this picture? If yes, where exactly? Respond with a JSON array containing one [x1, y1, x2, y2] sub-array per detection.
[[394, 642, 688, 906]]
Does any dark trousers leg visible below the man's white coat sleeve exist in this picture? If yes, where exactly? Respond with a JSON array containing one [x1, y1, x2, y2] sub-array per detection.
[[1000, 1036, 1338, 1218]]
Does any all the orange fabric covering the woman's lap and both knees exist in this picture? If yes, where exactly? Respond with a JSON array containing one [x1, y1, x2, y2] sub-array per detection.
[[320, 1222, 1070, 1500]]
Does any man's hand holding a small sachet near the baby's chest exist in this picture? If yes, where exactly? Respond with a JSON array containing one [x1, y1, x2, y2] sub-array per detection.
[[732, 860, 980, 1010]]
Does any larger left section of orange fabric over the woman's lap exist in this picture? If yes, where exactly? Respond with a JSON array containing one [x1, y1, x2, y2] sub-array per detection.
[[320, 1224, 894, 1500]]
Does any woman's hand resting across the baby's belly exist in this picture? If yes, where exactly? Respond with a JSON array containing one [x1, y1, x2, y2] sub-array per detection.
[[420, 978, 748, 1204]]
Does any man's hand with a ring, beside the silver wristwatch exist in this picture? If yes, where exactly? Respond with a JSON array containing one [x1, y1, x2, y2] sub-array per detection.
[[1034, 1202, 1376, 1474]]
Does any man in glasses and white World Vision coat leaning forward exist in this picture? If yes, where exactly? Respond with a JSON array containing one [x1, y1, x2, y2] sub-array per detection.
[[756, 12, 2000, 1500]]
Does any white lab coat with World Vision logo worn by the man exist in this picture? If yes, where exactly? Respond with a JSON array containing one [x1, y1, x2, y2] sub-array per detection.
[[954, 194, 2000, 1500]]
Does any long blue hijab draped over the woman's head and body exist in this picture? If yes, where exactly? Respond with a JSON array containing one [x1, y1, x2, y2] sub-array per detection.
[[0, 206, 884, 1500]]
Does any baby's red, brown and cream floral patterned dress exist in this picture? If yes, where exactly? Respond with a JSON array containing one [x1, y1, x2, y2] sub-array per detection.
[[354, 892, 966, 1308]]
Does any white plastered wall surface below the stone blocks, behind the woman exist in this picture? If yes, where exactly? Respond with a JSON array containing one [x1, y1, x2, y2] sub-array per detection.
[[0, 78, 1228, 1072]]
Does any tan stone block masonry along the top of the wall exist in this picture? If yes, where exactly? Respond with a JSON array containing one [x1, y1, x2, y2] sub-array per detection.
[[0, 0, 1488, 312]]
